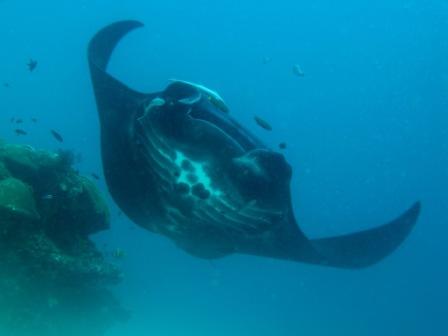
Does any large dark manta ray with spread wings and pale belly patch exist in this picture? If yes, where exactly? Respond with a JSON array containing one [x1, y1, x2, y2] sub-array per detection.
[[88, 21, 420, 269]]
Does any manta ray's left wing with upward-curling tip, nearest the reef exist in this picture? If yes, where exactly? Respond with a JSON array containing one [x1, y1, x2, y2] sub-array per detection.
[[88, 21, 161, 221]]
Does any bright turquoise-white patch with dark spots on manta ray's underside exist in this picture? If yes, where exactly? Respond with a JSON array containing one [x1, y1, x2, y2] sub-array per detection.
[[174, 150, 222, 197]]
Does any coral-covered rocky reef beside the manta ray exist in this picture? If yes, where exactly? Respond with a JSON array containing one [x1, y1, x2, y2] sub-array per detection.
[[0, 138, 128, 336]]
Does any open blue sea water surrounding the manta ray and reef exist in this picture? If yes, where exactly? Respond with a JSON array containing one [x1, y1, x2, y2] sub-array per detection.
[[0, 0, 448, 336]]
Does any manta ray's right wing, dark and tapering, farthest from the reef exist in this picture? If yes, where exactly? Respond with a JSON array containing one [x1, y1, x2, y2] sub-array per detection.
[[241, 197, 420, 269]]
